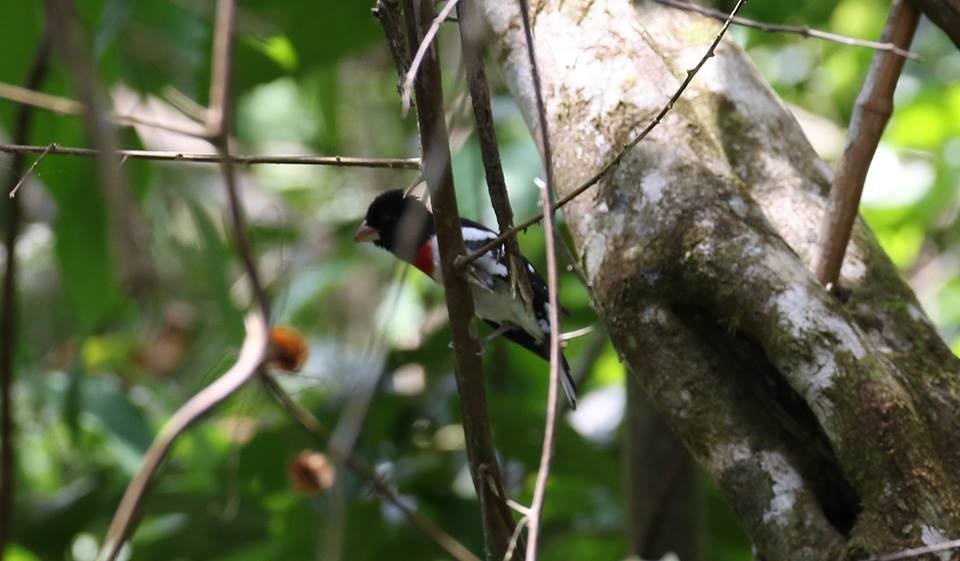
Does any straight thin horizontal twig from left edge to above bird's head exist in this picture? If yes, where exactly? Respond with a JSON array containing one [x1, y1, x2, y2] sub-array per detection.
[[0, 144, 420, 169]]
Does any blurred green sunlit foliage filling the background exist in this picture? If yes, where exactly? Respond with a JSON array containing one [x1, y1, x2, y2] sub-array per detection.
[[0, 0, 960, 561]]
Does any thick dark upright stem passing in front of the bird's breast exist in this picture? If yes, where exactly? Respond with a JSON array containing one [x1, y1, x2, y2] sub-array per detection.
[[404, 0, 515, 558]]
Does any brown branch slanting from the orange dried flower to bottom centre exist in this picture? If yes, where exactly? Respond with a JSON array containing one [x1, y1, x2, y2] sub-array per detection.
[[261, 375, 479, 561]]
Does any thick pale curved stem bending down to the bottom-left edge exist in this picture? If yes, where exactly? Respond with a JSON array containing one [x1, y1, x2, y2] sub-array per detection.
[[97, 311, 267, 561]]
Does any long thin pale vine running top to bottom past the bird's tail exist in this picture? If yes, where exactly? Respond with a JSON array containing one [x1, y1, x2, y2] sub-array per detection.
[[519, 0, 560, 561]]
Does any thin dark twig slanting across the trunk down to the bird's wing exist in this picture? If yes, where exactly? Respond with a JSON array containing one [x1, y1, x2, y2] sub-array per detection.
[[457, 0, 745, 268]]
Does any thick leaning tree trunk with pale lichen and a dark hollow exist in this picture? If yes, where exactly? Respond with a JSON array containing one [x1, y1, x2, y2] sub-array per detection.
[[483, 0, 960, 559]]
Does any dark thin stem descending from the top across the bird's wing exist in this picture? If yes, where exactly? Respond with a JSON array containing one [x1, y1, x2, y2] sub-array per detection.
[[457, 1, 533, 313]]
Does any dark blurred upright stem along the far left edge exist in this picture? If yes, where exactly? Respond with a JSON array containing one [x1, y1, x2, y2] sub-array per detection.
[[0, 30, 50, 552]]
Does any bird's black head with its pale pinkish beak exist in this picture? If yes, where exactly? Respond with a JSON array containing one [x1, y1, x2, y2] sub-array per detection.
[[353, 189, 433, 261]]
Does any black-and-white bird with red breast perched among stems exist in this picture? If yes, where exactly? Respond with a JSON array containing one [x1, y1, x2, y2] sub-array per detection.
[[353, 190, 577, 409]]
